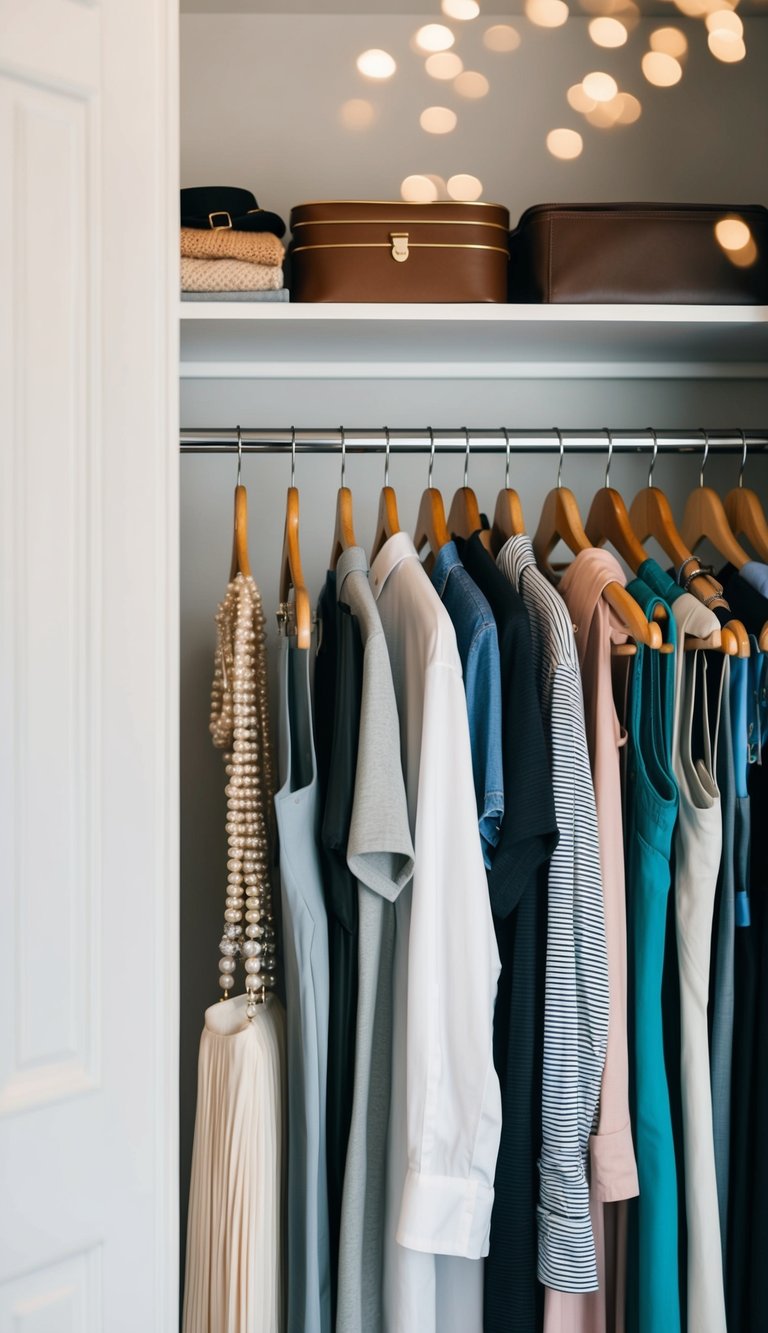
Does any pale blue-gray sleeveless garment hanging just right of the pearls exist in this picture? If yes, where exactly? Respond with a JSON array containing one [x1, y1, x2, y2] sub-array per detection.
[[275, 639, 331, 1333]]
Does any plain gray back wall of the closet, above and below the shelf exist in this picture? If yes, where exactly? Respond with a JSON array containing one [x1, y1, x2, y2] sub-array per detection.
[[181, 7, 768, 1269]]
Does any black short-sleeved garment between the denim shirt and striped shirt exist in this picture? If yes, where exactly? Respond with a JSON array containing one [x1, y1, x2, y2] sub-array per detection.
[[456, 533, 557, 1333]]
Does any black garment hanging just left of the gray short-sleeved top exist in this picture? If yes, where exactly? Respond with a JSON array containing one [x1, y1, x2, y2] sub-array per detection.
[[320, 589, 363, 1317]]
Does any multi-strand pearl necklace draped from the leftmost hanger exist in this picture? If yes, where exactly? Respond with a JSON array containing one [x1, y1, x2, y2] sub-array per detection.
[[209, 573, 276, 1018]]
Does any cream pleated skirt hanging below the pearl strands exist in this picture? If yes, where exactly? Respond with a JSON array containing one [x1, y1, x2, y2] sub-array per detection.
[[184, 996, 285, 1333]]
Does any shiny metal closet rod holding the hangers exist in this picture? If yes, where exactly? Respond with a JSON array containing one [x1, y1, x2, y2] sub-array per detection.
[[180, 427, 768, 453]]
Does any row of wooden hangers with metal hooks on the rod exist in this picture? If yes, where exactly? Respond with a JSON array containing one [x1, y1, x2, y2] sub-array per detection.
[[225, 427, 768, 657]]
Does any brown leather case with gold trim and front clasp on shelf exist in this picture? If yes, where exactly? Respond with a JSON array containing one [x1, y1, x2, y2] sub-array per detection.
[[289, 200, 509, 303]]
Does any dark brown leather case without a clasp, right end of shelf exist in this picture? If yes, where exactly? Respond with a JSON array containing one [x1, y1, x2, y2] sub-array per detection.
[[509, 204, 768, 305]]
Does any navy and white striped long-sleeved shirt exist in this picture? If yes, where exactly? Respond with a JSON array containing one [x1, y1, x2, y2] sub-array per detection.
[[497, 536, 608, 1292]]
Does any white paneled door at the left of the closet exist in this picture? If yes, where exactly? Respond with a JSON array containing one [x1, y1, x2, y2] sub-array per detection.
[[0, 0, 179, 1333]]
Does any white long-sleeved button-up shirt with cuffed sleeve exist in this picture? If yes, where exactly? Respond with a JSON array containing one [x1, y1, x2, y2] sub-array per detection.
[[371, 532, 501, 1333]]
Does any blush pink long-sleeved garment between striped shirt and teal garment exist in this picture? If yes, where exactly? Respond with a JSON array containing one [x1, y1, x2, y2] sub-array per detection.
[[554, 548, 639, 1333]]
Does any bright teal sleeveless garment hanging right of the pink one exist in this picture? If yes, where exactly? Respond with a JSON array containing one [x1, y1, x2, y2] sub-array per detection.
[[625, 573, 680, 1333]]
